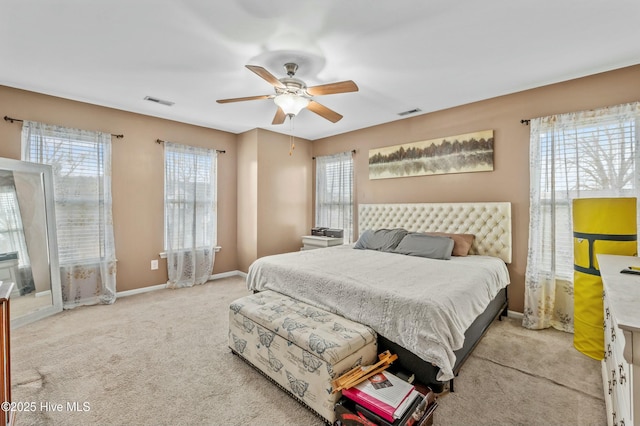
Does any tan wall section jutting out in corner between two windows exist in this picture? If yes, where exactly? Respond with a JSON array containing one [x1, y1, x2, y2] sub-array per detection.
[[238, 129, 313, 272]]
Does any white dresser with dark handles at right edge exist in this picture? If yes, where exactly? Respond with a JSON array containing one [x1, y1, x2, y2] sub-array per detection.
[[598, 254, 640, 426]]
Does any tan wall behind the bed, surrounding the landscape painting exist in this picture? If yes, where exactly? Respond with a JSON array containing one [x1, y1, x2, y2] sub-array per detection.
[[313, 66, 640, 312]]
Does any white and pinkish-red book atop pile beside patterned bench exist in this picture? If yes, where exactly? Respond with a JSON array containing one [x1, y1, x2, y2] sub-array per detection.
[[342, 371, 415, 423]]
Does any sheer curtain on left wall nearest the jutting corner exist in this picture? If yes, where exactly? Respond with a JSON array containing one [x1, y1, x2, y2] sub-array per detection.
[[164, 142, 217, 288]]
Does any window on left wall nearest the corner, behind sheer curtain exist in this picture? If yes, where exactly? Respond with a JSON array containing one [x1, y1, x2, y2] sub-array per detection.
[[164, 142, 217, 250]]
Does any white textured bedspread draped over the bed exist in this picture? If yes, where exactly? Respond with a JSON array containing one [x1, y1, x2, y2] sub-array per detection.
[[247, 245, 509, 381]]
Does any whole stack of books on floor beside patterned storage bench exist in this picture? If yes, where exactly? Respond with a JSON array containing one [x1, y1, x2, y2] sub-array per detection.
[[336, 371, 437, 426]]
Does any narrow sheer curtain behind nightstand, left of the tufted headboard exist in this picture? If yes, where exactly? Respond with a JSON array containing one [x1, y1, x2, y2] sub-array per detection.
[[316, 151, 353, 244]]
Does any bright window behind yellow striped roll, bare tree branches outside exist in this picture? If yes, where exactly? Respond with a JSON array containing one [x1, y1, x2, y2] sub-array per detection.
[[540, 111, 639, 281]]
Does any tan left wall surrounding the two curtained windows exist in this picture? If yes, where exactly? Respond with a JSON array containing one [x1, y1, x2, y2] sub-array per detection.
[[0, 86, 238, 291]]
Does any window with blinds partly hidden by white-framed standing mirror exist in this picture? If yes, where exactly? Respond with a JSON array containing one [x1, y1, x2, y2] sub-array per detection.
[[22, 122, 115, 266]]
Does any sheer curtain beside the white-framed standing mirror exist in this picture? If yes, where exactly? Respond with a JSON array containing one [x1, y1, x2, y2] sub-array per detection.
[[22, 121, 116, 308]]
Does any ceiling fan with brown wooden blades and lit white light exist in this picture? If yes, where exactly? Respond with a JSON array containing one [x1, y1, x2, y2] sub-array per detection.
[[216, 62, 358, 124]]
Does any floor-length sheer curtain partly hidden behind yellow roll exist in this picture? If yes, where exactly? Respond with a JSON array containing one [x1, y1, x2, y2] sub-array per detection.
[[523, 102, 640, 332]]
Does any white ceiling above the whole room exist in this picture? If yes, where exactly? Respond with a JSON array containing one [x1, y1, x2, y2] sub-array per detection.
[[0, 0, 640, 140]]
